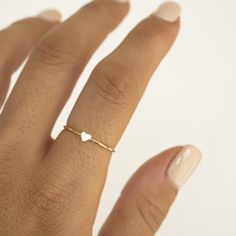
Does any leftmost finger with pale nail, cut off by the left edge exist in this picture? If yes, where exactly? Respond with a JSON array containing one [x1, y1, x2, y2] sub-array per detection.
[[0, 10, 60, 108]]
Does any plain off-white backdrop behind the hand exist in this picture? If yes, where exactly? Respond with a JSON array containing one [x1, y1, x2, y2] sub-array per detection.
[[0, 0, 236, 236]]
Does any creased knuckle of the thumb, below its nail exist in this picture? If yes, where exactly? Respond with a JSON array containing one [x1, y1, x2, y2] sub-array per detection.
[[136, 193, 169, 232]]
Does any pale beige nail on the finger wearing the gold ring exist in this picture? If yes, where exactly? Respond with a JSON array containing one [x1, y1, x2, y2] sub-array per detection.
[[154, 2, 181, 23]]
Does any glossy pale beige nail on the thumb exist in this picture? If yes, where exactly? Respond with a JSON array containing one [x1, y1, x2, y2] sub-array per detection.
[[167, 145, 202, 189]]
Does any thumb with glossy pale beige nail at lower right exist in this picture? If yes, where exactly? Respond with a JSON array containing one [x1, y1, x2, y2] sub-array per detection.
[[99, 145, 201, 236]]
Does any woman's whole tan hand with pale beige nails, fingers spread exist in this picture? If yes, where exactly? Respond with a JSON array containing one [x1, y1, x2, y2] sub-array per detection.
[[0, 0, 201, 236]]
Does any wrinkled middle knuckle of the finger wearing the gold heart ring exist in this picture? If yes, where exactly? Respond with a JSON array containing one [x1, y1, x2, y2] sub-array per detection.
[[93, 62, 140, 108]]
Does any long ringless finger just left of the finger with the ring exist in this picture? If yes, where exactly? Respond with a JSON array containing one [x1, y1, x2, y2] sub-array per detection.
[[0, 0, 129, 150]]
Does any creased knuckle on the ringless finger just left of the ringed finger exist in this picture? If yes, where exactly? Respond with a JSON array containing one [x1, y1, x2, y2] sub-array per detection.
[[36, 33, 78, 67]]
